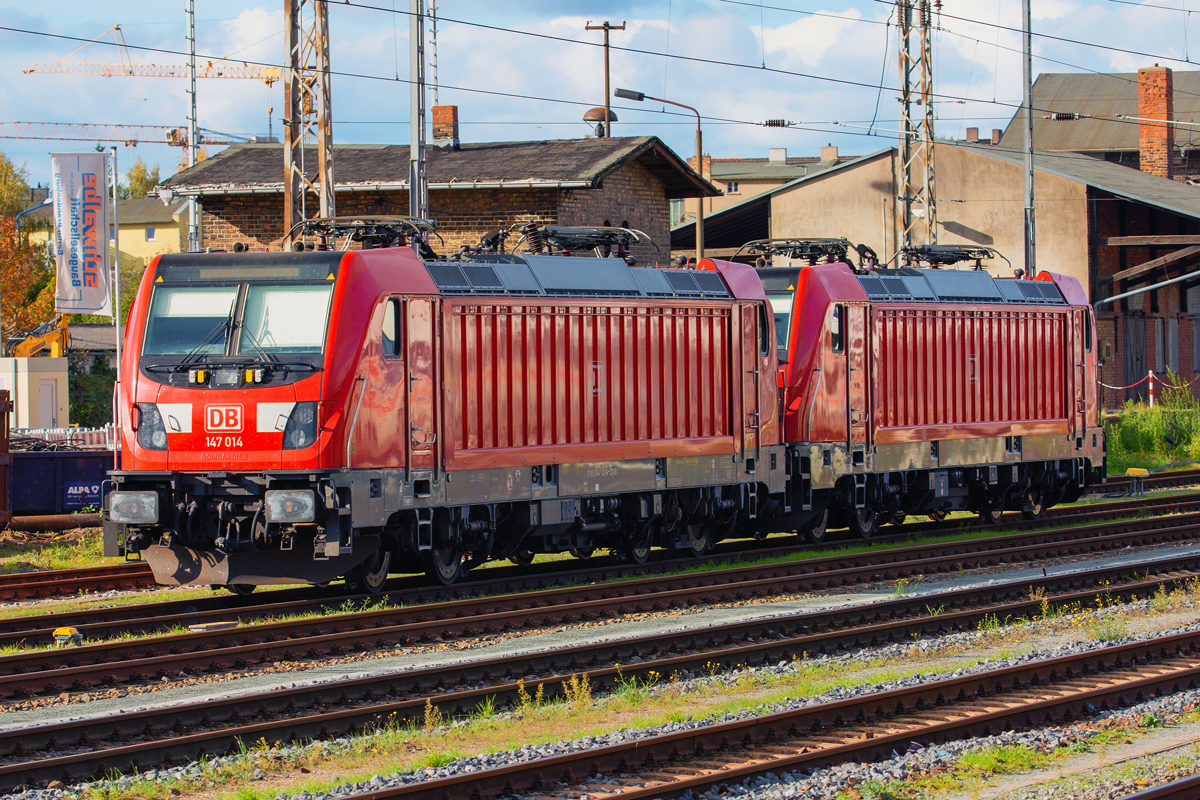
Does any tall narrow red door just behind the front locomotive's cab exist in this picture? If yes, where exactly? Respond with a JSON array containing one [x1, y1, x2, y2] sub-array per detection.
[[404, 296, 438, 469]]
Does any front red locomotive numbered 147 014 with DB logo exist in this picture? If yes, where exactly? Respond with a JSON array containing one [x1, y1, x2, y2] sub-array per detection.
[[106, 221, 786, 593]]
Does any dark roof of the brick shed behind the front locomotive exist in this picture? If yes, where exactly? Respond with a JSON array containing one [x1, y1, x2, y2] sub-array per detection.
[[161, 137, 720, 198]]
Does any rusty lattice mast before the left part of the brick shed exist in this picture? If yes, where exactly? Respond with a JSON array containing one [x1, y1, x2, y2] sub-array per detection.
[[283, 0, 337, 247]]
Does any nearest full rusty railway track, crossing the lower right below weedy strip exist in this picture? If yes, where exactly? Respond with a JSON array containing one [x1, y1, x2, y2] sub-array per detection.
[[328, 633, 1200, 800]]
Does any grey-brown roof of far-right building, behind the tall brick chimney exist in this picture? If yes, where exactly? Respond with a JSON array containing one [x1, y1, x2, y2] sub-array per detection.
[[1000, 72, 1200, 151]]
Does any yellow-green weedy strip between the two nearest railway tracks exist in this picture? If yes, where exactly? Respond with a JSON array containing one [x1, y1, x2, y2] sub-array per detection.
[[58, 583, 1200, 800]]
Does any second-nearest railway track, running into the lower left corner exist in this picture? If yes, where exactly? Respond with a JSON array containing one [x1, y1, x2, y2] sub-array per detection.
[[0, 555, 1200, 798]]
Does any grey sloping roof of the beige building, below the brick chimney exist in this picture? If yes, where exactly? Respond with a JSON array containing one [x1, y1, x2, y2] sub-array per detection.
[[960, 142, 1200, 219]]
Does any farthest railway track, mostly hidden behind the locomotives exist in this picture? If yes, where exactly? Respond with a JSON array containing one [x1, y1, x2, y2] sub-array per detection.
[[0, 470, 1200, 604]]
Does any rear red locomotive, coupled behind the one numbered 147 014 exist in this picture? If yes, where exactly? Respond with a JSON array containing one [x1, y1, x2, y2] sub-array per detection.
[[758, 241, 1105, 541]]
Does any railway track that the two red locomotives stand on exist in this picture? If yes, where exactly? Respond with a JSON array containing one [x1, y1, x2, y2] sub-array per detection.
[[0, 493, 1200, 646]]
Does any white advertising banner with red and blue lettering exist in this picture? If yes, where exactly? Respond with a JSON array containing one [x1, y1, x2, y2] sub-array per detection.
[[50, 152, 113, 317]]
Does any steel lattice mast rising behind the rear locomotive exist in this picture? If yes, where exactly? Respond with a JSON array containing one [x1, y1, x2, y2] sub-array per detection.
[[896, 0, 942, 249]]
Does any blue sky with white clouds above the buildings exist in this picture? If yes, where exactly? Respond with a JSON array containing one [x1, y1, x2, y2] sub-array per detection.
[[0, 0, 1185, 189]]
